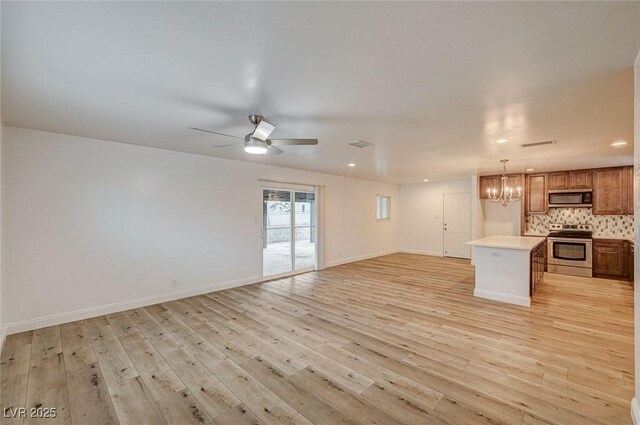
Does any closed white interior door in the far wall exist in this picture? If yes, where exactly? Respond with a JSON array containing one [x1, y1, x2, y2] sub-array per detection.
[[443, 193, 471, 258]]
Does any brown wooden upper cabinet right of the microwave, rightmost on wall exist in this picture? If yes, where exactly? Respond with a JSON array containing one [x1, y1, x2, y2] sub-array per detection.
[[593, 167, 629, 215]]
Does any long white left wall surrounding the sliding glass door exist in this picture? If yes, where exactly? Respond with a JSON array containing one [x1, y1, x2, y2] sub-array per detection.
[[3, 127, 400, 332]]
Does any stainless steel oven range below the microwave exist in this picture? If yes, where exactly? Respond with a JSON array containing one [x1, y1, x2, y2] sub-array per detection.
[[547, 237, 593, 277]]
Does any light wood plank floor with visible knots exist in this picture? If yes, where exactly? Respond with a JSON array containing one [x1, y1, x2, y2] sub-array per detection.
[[1, 254, 634, 425]]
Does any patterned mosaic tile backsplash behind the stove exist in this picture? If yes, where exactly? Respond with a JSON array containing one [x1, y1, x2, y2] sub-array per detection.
[[525, 208, 634, 239]]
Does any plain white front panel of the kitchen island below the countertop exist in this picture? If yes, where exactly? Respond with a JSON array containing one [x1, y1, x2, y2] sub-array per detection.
[[473, 246, 531, 307]]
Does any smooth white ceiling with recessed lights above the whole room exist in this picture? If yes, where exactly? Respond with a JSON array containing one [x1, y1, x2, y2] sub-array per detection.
[[2, 2, 640, 183]]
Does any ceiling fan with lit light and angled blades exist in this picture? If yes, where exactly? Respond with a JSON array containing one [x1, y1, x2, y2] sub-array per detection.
[[189, 115, 318, 155]]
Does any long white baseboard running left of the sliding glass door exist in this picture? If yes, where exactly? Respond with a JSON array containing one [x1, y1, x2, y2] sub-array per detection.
[[2, 277, 262, 336]]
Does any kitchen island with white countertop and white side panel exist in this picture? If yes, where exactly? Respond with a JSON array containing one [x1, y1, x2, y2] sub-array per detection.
[[467, 236, 545, 307]]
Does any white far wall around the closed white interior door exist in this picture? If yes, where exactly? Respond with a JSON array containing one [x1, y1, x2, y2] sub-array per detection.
[[400, 180, 473, 255]]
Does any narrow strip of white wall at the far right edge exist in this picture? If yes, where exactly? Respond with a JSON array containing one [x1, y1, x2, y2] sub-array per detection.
[[631, 48, 640, 425]]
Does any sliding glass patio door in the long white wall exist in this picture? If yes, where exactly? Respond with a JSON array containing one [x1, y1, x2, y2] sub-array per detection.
[[262, 189, 316, 277]]
